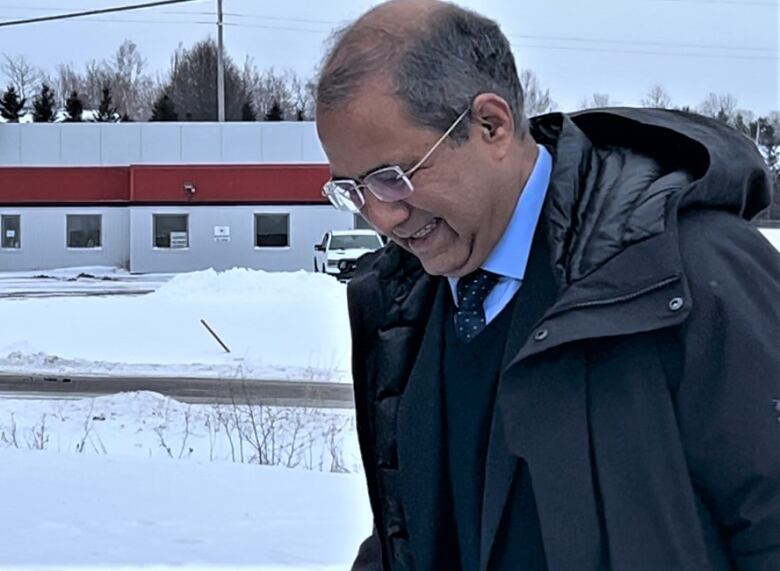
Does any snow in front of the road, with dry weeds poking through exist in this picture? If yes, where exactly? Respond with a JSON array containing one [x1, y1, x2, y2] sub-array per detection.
[[0, 393, 371, 571]]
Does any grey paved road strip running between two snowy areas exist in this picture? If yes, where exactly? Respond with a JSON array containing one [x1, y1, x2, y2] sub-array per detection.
[[0, 374, 354, 408]]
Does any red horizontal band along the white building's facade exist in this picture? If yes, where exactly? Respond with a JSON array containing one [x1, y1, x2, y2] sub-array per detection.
[[0, 165, 330, 205]]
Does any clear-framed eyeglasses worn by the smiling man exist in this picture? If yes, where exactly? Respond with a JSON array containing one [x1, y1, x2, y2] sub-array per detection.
[[322, 109, 469, 212]]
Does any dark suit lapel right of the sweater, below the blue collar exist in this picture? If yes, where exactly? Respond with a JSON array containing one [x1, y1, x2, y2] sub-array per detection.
[[480, 214, 557, 571]]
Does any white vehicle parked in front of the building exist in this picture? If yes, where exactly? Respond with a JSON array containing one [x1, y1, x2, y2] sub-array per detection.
[[314, 230, 384, 279]]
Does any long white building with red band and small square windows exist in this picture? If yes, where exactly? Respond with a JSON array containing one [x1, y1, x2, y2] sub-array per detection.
[[0, 122, 356, 272]]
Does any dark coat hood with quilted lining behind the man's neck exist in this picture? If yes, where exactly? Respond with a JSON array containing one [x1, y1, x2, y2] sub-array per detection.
[[531, 108, 771, 287]]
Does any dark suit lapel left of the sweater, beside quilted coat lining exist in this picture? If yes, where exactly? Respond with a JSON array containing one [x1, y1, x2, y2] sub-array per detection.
[[398, 279, 451, 569]]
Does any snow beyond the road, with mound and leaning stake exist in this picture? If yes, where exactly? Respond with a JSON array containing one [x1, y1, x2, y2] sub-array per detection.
[[0, 268, 350, 382]]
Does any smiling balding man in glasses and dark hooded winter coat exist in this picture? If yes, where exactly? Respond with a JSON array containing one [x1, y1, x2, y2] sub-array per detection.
[[317, 0, 780, 571]]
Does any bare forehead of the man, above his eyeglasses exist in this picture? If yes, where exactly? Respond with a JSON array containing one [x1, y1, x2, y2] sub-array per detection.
[[317, 90, 431, 178]]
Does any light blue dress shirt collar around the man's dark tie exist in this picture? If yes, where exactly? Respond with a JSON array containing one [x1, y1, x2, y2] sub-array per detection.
[[447, 145, 552, 323]]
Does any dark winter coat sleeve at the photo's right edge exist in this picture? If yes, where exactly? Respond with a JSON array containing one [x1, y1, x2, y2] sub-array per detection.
[[676, 213, 780, 571]]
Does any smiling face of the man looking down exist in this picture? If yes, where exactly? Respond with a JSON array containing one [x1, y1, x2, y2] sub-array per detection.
[[317, 90, 501, 276]]
